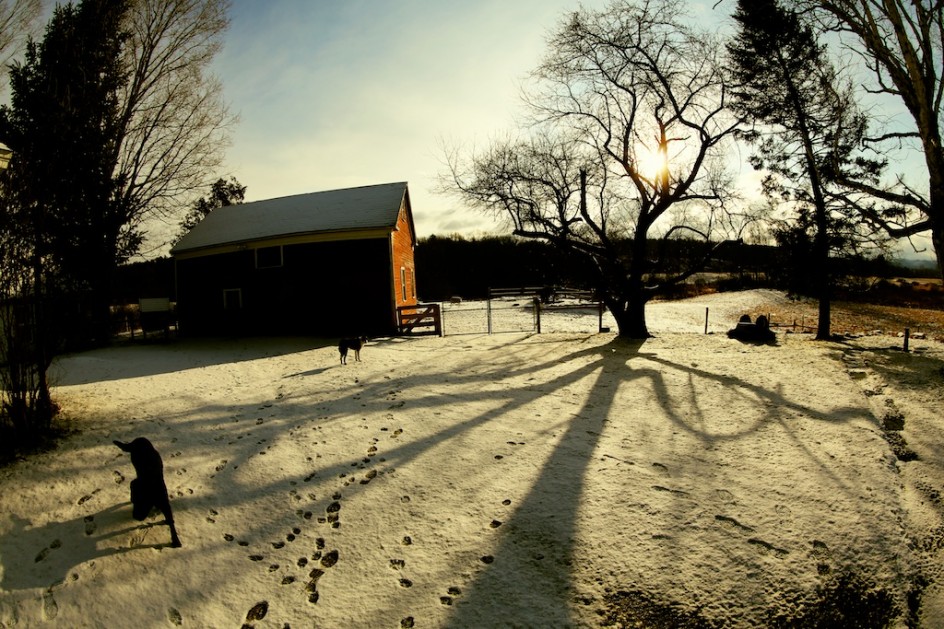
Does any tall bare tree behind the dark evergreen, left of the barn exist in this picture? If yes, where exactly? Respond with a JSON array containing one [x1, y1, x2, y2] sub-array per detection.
[[116, 0, 235, 258]]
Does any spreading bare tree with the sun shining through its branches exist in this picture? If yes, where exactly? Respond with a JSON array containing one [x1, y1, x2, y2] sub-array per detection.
[[447, 0, 745, 338]]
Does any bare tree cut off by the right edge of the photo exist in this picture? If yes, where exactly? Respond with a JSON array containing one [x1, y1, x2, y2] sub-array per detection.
[[793, 0, 944, 274]]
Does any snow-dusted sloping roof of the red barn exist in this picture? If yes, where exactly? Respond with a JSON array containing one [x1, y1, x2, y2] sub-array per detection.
[[171, 182, 412, 255]]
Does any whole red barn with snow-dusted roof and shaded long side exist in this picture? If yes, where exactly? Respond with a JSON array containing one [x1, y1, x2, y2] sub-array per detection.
[[171, 182, 416, 336]]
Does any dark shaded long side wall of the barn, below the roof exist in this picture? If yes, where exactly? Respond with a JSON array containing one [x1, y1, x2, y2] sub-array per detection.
[[177, 239, 395, 336]]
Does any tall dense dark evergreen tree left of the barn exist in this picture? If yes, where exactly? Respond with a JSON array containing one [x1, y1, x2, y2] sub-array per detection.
[[0, 0, 129, 342]]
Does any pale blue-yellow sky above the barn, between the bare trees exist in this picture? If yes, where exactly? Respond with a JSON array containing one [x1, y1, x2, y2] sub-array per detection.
[[215, 0, 724, 237]]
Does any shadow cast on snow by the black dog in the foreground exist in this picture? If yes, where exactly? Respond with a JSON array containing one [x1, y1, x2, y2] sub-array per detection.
[[0, 502, 170, 591]]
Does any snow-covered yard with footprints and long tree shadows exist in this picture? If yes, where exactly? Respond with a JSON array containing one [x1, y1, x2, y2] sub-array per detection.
[[0, 291, 944, 627]]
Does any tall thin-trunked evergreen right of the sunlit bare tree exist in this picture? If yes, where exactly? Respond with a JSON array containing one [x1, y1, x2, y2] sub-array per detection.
[[728, 0, 865, 339]]
